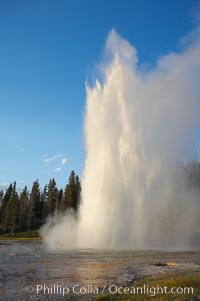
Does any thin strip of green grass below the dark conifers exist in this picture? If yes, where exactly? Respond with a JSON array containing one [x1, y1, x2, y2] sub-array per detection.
[[0, 230, 41, 240]]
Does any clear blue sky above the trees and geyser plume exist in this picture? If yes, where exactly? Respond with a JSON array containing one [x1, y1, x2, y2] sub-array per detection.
[[0, 0, 199, 187]]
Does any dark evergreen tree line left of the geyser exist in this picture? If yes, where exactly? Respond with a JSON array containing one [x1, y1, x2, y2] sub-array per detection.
[[0, 171, 81, 234]]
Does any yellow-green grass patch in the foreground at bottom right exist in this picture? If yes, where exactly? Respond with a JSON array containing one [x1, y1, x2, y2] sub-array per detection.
[[95, 270, 200, 301]]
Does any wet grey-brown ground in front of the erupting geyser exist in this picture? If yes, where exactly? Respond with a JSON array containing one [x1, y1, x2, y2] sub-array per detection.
[[0, 241, 200, 301]]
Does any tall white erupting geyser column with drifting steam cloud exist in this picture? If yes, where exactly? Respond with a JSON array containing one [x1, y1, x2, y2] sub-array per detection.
[[43, 31, 200, 248]]
